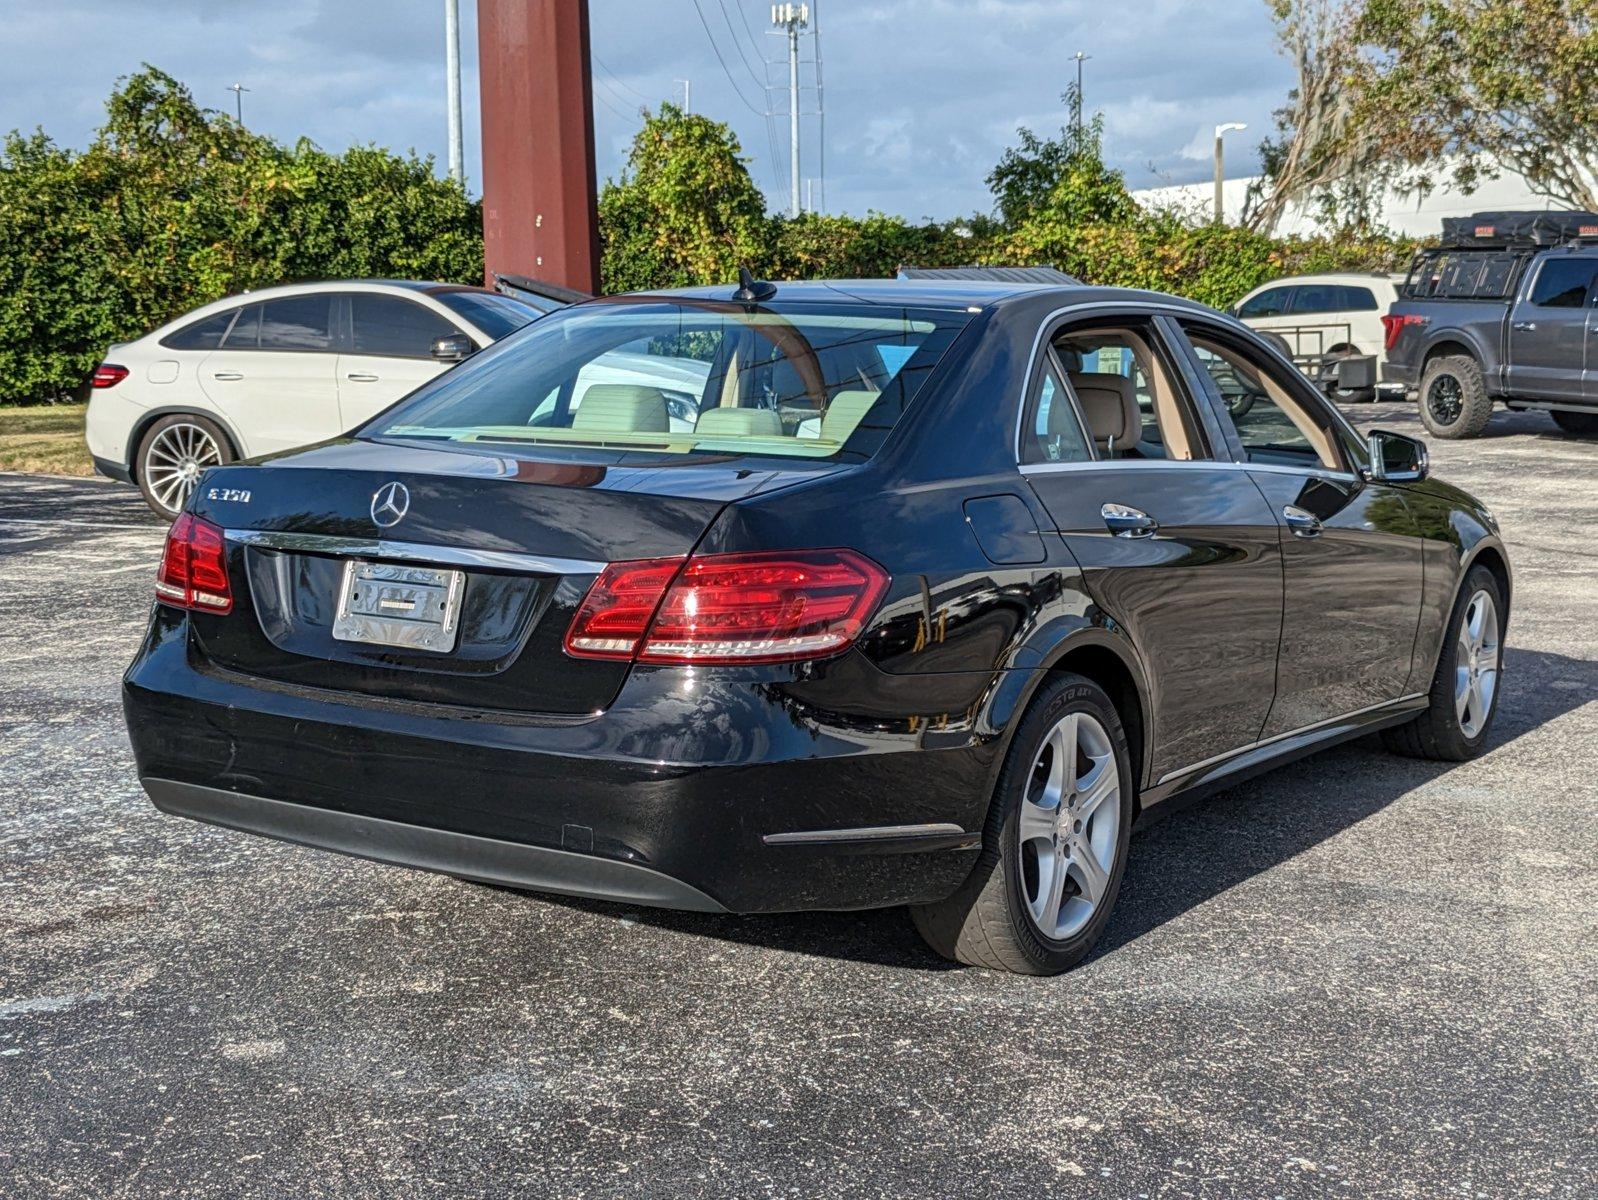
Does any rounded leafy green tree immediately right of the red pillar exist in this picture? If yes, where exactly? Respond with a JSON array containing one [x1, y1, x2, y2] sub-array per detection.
[[599, 104, 770, 292]]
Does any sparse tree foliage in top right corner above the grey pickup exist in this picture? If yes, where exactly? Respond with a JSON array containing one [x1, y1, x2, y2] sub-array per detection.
[[1357, 0, 1598, 209]]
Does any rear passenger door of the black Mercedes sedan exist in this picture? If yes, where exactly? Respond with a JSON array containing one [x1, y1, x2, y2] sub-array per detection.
[[1021, 315, 1282, 783]]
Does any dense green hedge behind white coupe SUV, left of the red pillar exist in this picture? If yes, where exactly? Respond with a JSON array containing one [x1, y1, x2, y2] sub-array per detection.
[[0, 69, 483, 403]]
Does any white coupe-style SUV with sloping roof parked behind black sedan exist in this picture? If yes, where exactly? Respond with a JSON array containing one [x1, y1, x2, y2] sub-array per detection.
[[86, 280, 555, 518]]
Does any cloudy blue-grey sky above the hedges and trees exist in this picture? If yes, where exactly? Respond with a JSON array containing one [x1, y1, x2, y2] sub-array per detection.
[[0, 0, 1291, 217]]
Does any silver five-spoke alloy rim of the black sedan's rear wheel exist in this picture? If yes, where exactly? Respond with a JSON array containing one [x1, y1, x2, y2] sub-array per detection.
[[1016, 713, 1120, 941]]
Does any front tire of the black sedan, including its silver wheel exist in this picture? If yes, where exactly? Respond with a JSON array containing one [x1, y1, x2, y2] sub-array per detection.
[[1382, 566, 1507, 762]]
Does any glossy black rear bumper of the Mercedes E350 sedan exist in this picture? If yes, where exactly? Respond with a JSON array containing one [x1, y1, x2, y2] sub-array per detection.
[[123, 609, 999, 912]]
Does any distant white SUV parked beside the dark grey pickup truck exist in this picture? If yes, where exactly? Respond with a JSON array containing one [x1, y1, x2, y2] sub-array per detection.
[[1232, 273, 1405, 401]]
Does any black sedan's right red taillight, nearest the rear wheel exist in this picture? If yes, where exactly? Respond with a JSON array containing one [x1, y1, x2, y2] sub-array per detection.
[[566, 550, 888, 663]]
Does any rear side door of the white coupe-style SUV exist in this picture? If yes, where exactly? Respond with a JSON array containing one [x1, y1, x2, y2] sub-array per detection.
[[200, 292, 342, 454]]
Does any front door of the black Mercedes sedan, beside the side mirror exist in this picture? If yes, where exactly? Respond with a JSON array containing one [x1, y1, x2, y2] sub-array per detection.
[[1178, 320, 1422, 738]]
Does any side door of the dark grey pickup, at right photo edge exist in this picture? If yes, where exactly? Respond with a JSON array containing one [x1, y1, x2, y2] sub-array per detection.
[[1505, 252, 1598, 399]]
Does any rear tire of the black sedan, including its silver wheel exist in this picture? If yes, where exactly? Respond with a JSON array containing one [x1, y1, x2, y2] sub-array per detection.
[[911, 674, 1133, 975]]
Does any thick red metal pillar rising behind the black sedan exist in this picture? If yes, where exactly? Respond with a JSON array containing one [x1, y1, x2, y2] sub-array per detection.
[[478, 0, 599, 292]]
